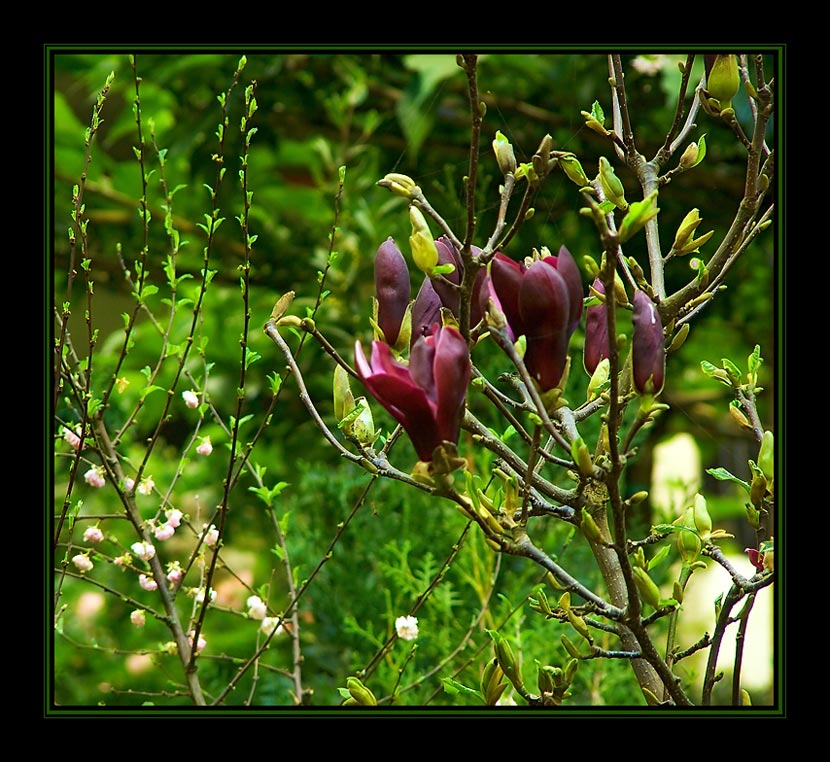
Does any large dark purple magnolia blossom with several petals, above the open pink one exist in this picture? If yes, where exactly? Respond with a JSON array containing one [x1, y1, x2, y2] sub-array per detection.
[[488, 246, 583, 392]]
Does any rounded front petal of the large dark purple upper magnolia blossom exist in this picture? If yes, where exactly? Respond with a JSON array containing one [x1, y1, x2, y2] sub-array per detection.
[[519, 257, 571, 392]]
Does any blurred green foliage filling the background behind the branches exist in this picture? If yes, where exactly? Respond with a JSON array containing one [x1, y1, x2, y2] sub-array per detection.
[[50, 49, 775, 706]]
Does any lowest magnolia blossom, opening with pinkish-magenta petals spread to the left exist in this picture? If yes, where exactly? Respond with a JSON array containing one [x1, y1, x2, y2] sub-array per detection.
[[355, 325, 470, 462]]
